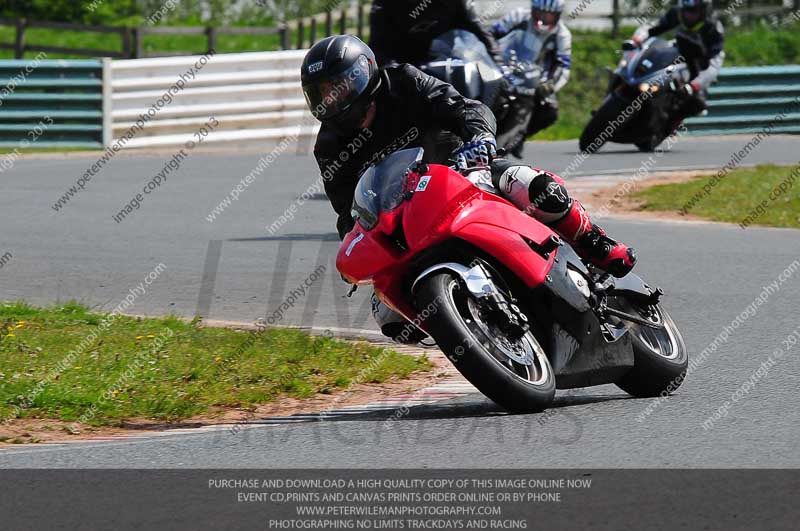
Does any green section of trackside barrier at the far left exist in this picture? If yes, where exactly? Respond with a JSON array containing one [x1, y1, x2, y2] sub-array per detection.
[[0, 59, 111, 148]]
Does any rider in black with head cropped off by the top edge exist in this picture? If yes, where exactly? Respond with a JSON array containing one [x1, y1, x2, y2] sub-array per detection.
[[369, 0, 502, 66]]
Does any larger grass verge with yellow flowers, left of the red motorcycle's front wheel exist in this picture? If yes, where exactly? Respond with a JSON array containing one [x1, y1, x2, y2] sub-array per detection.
[[0, 303, 431, 425]]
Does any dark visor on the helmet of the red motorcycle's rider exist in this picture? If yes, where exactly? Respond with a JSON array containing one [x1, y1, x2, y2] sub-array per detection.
[[303, 55, 370, 121]]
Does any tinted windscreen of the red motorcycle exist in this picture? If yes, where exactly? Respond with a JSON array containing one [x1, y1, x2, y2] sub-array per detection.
[[351, 148, 425, 230]]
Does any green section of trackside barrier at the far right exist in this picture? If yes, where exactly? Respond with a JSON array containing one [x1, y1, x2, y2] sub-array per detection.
[[686, 65, 800, 135]]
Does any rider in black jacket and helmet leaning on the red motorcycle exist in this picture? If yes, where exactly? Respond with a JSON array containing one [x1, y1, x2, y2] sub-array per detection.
[[301, 35, 636, 340]]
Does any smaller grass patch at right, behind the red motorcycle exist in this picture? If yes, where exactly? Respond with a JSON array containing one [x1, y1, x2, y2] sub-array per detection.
[[633, 165, 800, 228]]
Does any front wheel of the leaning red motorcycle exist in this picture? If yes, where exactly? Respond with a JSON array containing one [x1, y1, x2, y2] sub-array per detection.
[[417, 272, 556, 412]]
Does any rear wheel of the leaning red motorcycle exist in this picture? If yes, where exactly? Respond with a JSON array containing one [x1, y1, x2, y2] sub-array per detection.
[[617, 305, 689, 397]]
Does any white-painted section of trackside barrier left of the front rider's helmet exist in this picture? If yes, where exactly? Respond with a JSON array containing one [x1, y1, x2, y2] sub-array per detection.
[[111, 50, 319, 147]]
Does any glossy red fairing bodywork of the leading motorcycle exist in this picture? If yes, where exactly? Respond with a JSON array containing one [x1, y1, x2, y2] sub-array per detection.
[[336, 165, 556, 317]]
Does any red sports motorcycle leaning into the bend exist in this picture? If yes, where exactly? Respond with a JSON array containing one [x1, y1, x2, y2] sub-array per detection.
[[336, 149, 688, 412]]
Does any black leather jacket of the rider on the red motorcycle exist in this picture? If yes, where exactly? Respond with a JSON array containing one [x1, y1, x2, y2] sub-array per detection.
[[314, 64, 497, 238]]
